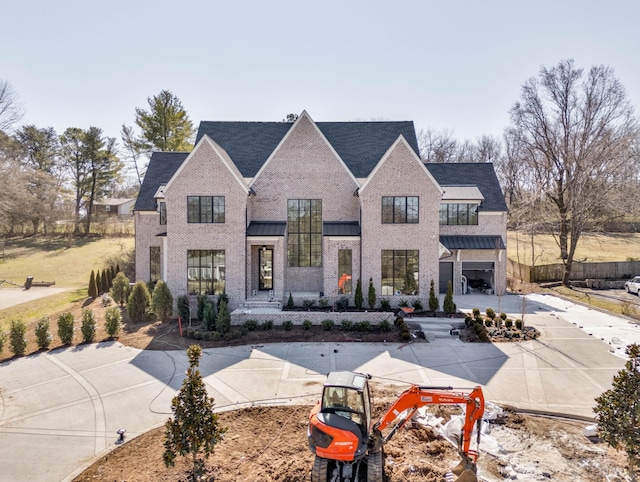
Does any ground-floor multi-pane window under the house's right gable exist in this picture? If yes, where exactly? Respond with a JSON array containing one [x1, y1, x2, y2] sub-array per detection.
[[381, 249, 420, 296]]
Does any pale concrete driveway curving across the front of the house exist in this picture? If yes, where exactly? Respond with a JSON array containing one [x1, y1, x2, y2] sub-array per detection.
[[0, 295, 640, 482]]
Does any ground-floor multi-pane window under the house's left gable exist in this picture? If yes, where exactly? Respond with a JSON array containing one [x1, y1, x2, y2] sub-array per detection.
[[187, 249, 225, 295]]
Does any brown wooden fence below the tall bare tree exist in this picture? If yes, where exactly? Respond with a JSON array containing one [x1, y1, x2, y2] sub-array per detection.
[[507, 259, 640, 283]]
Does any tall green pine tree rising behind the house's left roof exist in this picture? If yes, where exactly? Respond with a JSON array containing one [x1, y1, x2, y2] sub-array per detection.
[[135, 90, 194, 152]]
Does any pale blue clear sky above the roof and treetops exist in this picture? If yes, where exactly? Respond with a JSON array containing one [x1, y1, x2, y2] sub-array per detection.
[[0, 0, 640, 145]]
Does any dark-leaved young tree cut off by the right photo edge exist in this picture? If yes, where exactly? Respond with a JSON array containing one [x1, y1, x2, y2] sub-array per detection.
[[593, 344, 640, 480]]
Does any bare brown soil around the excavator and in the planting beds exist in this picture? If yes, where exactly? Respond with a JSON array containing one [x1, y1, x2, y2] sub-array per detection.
[[0, 299, 630, 482]]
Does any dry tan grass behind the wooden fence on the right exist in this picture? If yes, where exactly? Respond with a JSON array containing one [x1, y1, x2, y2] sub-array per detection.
[[507, 231, 640, 265]]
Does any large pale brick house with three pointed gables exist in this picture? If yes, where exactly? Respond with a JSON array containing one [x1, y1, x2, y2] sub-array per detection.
[[134, 112, 507, 308]]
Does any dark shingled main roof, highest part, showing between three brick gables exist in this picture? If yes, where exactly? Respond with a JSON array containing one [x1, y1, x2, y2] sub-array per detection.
[[196, 121, 419, 178]]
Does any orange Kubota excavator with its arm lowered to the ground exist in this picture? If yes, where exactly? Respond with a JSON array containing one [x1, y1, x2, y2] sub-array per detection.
[[307, 371, 484, 482]]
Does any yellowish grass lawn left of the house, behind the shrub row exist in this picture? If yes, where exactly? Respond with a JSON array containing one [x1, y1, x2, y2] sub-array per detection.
[[0, 236, 134, 330]]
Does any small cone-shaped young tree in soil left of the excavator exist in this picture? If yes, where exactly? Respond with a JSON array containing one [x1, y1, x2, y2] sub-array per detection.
[[163, 345, 227, 481]]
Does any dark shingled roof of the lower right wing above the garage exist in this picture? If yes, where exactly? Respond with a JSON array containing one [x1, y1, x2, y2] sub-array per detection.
[[424, 162, 507, 211]]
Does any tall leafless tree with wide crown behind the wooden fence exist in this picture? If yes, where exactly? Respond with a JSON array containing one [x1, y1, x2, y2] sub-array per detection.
[[511, 60, 638, 286]]
